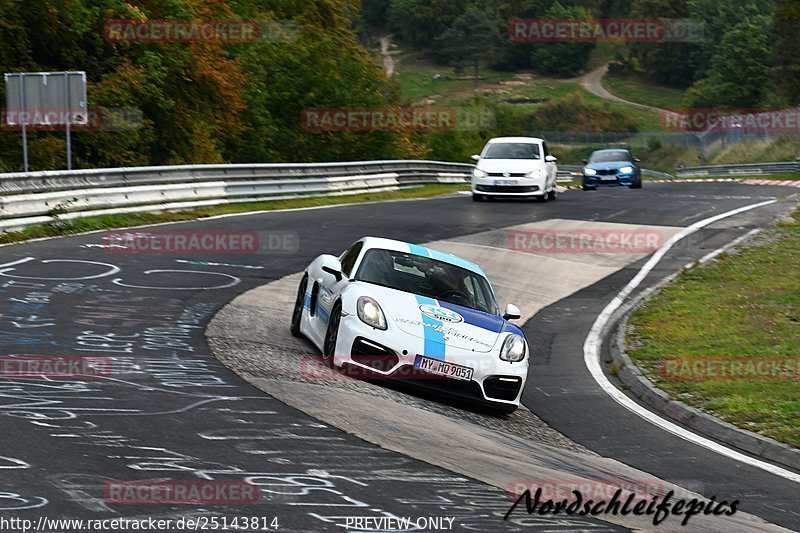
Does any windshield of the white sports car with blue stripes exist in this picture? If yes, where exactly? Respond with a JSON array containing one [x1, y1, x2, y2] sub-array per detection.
[[355, 249, 499, 315]]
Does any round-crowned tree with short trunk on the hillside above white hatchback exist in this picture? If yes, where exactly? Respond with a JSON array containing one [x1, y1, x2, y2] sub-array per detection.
[[436, 5, 503, 91]]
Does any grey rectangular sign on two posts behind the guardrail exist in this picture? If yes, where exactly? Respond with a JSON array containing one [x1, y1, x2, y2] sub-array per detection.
[[5, 72, 89, 172]]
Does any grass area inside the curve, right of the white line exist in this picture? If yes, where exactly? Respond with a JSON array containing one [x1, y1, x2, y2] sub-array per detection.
[[628, 206, 800, 447]]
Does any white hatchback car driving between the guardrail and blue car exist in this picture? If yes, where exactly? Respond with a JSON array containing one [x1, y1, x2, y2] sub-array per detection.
[[472, 137, 558, 202]]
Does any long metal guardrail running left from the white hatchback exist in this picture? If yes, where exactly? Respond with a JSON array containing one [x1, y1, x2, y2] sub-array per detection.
[[0, 161, 474, 231]]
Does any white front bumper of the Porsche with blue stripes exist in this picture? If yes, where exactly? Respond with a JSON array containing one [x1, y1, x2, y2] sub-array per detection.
[[334, 315, 528, 406]]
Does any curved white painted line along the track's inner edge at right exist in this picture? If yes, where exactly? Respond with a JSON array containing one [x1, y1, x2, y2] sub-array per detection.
[[583, 200, 800, 483]]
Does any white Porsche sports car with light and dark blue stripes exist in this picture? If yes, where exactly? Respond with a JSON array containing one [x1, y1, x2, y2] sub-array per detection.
[[291, 237, 529, 413]]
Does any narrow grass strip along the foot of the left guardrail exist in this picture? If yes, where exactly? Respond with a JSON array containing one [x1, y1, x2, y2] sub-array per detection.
[[0, 184, 468, 244]]
